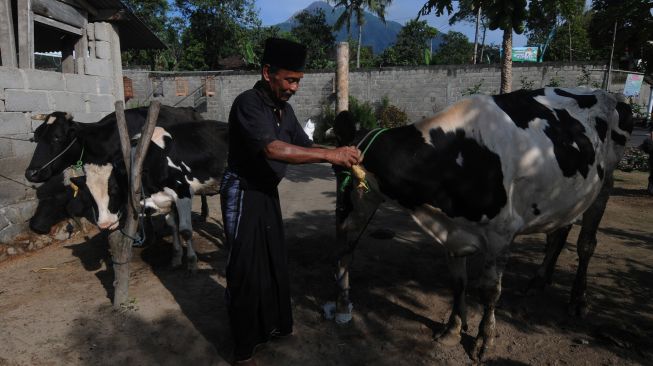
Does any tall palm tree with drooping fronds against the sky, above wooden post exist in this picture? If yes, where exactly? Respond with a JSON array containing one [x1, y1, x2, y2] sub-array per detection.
[[329, 0, 392, 68]]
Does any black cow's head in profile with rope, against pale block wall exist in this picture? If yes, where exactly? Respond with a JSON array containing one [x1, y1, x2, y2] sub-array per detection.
[[25, 112, 82, 183]]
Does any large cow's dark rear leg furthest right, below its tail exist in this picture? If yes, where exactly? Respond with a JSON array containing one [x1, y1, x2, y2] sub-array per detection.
[[568, 174, 614, 318]]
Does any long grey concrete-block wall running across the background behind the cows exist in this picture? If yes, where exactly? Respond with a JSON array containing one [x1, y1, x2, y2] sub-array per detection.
[[123, 63, 650, 123]]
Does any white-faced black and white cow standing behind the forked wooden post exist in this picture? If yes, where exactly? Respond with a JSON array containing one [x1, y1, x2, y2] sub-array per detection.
[[75, 120, 228, 271]]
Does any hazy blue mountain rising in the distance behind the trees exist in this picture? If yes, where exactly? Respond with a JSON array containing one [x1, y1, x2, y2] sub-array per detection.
[[275, 1, 403, 54]]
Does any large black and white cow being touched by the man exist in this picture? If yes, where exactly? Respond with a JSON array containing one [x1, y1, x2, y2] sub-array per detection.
[[334, 88, 632, 359]]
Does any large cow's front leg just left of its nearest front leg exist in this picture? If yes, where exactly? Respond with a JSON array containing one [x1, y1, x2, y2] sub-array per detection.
[[436, 253, 467, 346]]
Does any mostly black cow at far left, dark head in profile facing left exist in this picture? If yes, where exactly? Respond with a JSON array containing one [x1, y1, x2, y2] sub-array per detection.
[[25, 105, 208, 233]]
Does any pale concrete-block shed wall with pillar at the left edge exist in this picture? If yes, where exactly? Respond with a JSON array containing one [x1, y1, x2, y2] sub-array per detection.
[[0, 23, 123, 246]]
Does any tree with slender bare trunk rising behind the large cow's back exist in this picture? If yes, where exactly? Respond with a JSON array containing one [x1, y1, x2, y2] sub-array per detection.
[[420, 0, 527, 93]]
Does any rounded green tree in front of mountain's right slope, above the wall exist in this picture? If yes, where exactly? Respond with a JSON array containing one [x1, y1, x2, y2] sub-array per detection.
[[392, 19, 438, 65]]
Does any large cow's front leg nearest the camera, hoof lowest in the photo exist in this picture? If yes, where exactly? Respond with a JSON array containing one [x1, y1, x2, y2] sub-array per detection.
[[471, 246, 509, 361]]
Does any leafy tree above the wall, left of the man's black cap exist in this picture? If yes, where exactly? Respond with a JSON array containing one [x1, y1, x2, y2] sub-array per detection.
[[175, 0, 261, 70]]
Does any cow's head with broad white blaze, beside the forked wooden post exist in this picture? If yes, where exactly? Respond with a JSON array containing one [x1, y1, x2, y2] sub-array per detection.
[[70, 163, 127, 230]]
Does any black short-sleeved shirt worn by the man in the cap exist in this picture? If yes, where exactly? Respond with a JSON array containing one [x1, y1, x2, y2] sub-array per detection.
[[228, 80, 313, 189]]
